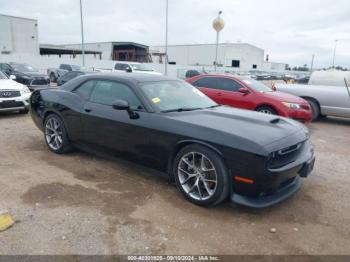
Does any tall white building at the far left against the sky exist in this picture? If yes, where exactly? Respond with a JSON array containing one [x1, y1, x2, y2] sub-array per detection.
[[0, 14, 39, 55]]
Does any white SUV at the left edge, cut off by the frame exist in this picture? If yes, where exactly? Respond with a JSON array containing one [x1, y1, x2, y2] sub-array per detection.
[[0, 71, 31, 114]]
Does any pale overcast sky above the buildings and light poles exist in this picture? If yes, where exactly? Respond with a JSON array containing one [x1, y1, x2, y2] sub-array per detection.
[[0, 0, 350, 68]]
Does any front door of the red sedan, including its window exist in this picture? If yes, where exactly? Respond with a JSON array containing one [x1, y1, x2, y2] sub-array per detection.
[[216, 77, 255, 109]]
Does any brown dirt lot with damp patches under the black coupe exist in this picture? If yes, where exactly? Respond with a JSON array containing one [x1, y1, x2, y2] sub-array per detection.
[[0, 114, 350, 254]]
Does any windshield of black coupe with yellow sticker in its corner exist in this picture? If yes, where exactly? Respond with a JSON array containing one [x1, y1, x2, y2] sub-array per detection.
[[141, 80, 217, 111]]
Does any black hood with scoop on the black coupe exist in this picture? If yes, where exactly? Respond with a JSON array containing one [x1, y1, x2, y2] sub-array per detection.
[[166, 106, 308, 155]]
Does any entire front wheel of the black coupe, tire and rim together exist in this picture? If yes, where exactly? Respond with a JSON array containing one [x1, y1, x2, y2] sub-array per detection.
[[173, 144, 230, 206]]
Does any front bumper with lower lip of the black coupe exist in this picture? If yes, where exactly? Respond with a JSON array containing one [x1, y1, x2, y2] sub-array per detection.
[[231, 142, 315, 208]]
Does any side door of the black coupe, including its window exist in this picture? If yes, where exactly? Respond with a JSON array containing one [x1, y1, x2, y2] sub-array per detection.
[[81, 80, 146, 160]]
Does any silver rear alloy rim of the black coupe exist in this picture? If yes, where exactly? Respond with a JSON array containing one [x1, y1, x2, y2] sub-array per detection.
[[45, 118, 63, 150]]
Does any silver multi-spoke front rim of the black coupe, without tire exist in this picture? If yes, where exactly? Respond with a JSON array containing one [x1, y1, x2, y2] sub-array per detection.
[[177, 152, 218, 201]]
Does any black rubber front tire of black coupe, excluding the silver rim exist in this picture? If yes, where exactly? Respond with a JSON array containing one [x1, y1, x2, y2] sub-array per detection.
[[173, 144, 230, 206]]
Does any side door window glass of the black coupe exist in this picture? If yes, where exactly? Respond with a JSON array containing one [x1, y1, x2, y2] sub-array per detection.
[[90, 81, 143, 109]]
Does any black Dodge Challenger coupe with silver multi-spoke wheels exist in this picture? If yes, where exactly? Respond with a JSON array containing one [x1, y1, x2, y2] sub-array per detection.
[[30, 73, 315, 208]]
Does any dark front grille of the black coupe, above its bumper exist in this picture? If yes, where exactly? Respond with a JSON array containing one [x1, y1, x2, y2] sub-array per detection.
[[268, 142, 305, 169]]
